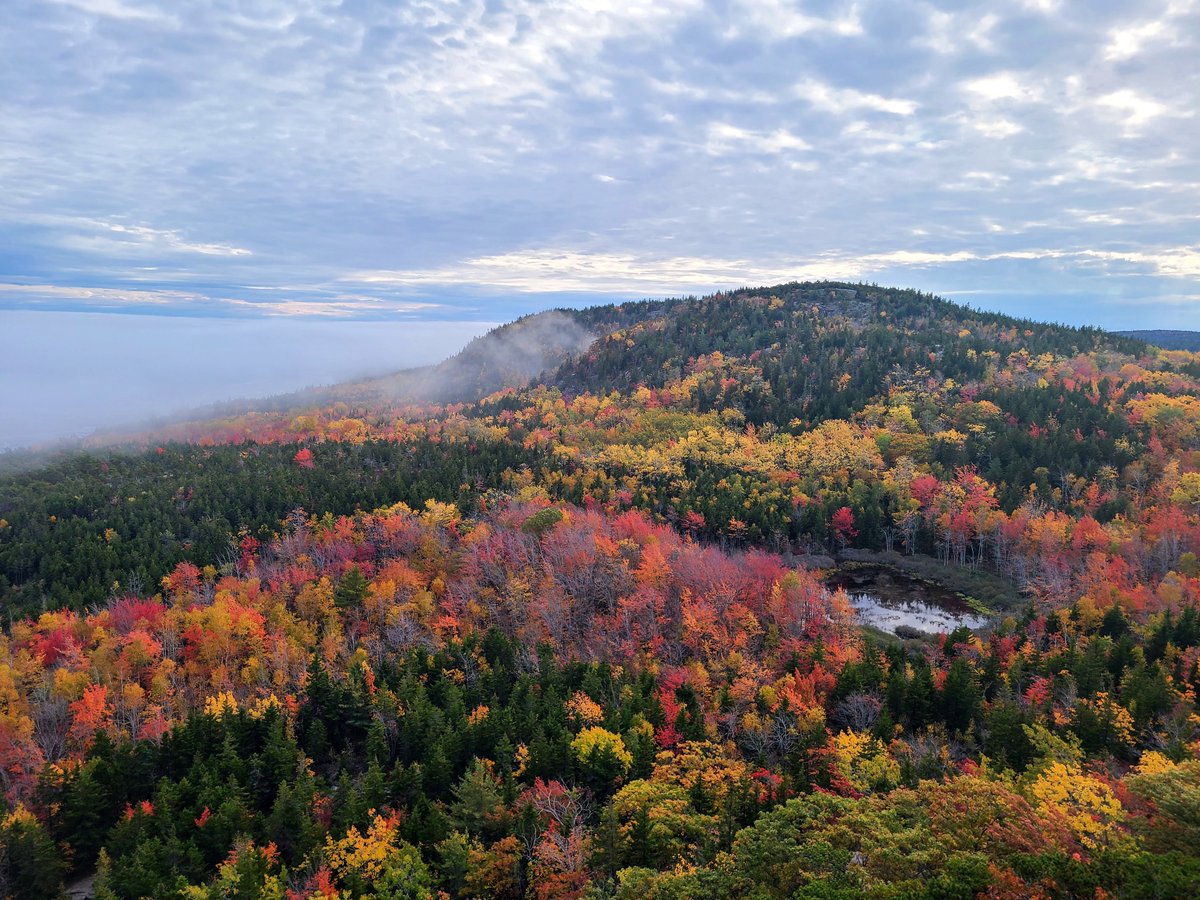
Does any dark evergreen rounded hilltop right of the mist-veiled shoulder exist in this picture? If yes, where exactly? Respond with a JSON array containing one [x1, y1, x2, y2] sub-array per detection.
[[550, 282, 1146, 425]]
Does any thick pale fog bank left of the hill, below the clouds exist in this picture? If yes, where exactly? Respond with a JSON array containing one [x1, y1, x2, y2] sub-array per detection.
[[0, 311, 494, 449]]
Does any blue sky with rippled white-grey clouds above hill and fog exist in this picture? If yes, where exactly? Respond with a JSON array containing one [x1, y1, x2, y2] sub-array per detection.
[[0, 0, 1200, 328]]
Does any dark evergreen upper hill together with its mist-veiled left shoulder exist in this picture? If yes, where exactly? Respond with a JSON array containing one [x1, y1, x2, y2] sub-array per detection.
[[321, 282, 1157, 415]]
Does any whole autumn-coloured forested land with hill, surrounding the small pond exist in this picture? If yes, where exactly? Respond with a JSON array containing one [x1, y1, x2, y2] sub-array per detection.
[[0, 282, 1200, 900]]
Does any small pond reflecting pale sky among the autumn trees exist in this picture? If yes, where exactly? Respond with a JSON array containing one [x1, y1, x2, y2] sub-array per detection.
[[826, 566, 988, 635]]
